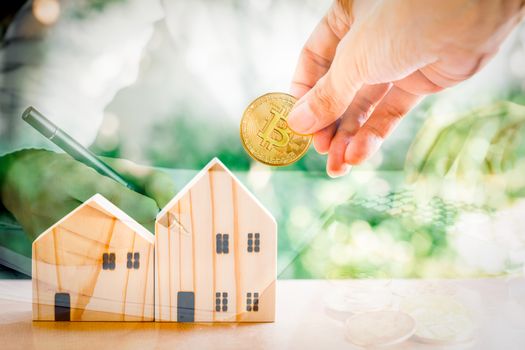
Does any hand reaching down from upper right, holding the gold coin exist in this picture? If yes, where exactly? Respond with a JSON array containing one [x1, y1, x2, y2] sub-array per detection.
[[288, 0, 525, 176]]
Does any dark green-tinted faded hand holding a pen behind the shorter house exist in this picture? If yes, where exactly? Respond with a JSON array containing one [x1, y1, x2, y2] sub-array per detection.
[[0, 149, 175, 239]]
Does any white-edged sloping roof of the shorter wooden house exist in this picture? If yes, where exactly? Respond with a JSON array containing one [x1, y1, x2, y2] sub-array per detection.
[[33, 193, 155, 244]]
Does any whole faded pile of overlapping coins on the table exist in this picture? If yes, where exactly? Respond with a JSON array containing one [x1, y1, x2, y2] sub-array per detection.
[[324, 280, 475, 347]]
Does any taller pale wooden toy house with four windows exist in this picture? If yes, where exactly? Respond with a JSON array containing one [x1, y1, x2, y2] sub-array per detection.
[[155, 158, 277, 322]]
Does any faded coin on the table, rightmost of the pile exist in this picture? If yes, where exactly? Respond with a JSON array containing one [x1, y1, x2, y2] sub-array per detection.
[[400, 294, 475, 345]]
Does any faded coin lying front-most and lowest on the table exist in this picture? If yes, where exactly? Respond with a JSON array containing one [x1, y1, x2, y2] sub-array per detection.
[[345, 311, 416, 348]]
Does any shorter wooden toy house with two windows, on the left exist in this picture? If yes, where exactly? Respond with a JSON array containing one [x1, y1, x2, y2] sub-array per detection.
[[32, 194, 154, 321]]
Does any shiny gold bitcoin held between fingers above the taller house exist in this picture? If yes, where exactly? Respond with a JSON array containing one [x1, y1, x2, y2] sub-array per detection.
[[241, 92, 312, 166]]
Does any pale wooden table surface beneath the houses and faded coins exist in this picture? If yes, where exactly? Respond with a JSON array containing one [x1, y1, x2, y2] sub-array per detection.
[[0, 277, 525, 350]]
